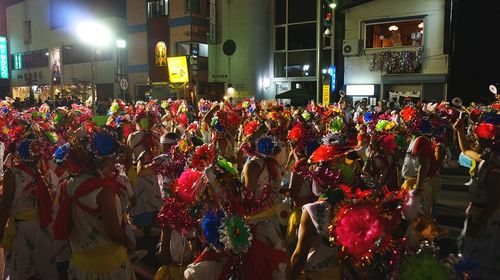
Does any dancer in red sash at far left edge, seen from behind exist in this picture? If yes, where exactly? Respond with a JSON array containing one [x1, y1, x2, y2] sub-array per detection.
[[0, 137, 59, 280]]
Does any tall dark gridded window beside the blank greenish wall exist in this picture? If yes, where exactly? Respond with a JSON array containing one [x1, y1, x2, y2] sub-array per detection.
[[274, 0, 331, 78]]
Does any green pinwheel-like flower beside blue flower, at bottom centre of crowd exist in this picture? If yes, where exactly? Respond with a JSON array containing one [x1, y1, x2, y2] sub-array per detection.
[[219, 215, 252, 254]]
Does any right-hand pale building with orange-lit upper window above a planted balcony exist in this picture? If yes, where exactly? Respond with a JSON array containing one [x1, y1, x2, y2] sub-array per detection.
[[342, 0, 448, 102]]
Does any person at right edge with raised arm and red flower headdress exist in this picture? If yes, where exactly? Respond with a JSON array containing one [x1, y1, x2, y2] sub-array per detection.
[[454, 115, 500, 279]]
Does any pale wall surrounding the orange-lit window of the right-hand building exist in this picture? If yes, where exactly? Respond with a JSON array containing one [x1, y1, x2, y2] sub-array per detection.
[[344, 0, 448, 87]]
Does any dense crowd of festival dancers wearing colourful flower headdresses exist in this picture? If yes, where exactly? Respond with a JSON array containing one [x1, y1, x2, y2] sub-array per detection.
[[0, 91, 500, 280]]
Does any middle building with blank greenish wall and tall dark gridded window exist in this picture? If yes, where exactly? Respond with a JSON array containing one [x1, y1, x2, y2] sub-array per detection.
[[209, 0, 332, 102]]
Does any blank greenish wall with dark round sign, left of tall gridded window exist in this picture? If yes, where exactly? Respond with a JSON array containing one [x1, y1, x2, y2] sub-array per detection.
[[208, 0, 274, 99]]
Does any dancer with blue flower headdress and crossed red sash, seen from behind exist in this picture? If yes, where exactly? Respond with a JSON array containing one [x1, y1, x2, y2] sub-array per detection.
[[54, 130, 135, 280]]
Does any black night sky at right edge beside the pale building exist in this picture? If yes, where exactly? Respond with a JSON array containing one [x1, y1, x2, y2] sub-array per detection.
[[448, 0, 500, 103]]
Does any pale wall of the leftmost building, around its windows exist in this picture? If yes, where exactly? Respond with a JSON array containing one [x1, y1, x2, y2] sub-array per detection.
[[7, 0, 125, 96]]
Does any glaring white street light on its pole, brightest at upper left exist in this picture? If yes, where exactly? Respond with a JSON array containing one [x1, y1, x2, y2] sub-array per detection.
[[77, 21, 112, 113]]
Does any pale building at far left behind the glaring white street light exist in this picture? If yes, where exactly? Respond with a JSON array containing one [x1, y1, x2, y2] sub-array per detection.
[[6, 0, 125, 106]]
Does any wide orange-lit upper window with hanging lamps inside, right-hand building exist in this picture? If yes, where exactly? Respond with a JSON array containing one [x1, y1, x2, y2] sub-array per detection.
[[365, 17, 424, 48]]
